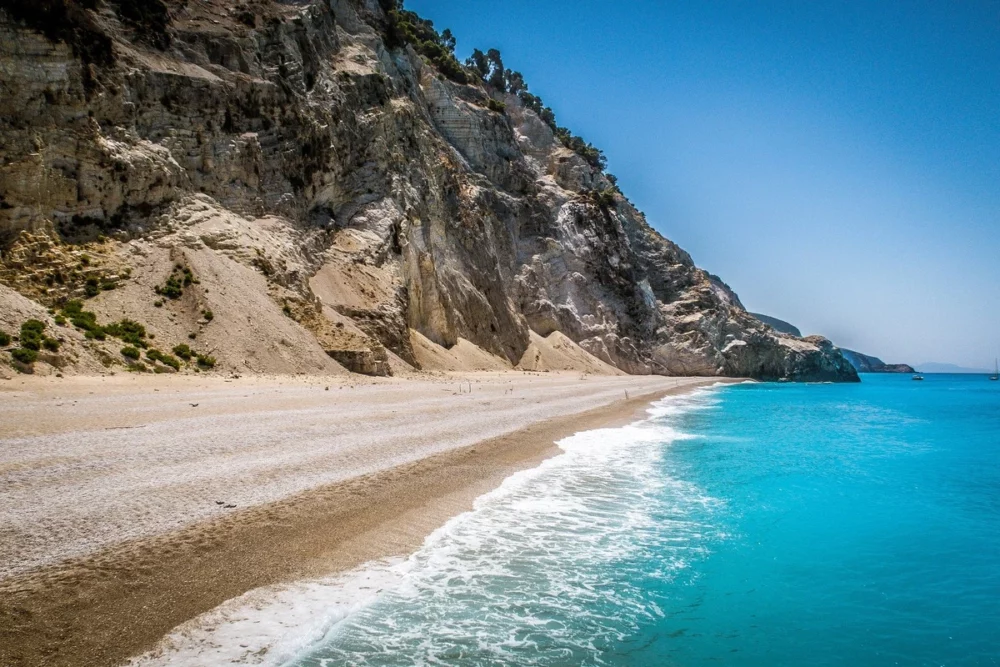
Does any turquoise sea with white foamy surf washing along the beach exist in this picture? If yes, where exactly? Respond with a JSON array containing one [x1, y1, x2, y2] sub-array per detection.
[[292, 375, 1000, 667]]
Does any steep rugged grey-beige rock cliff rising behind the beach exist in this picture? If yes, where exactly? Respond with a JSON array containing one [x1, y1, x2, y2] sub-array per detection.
[[0, 0, 857, 380]]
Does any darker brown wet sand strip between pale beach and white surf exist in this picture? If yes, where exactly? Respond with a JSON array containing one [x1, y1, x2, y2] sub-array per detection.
[[0, 378, 725, 665]]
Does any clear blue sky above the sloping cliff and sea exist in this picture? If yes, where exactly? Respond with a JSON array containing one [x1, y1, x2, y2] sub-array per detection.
[[406, 0, 1000, 367]]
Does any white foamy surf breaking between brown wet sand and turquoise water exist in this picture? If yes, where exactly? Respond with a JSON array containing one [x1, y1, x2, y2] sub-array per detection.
[[133, 390, 718, 667]]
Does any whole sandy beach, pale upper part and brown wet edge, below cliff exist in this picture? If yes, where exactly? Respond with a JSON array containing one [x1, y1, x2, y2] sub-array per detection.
[[0, 373, 716, 665]]
